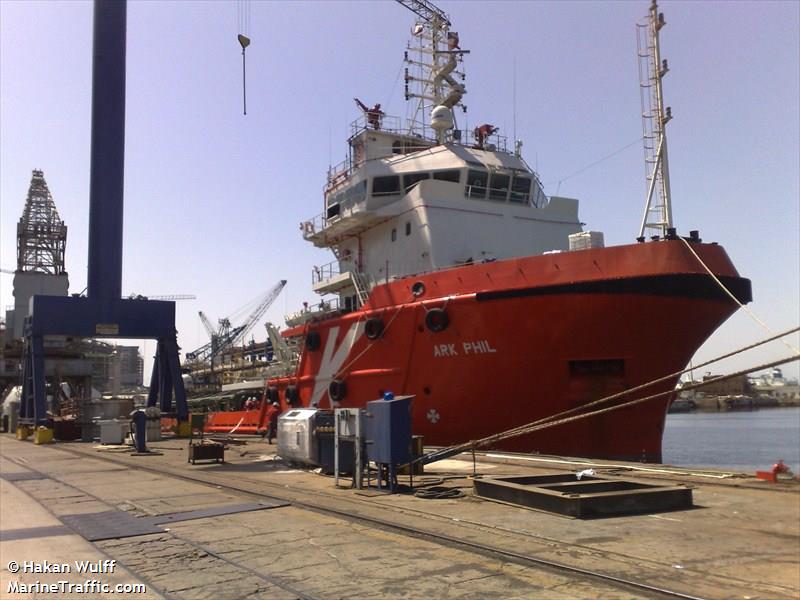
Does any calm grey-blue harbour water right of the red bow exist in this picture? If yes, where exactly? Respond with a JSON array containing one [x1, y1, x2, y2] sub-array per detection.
[[662, 407, 800, 474]]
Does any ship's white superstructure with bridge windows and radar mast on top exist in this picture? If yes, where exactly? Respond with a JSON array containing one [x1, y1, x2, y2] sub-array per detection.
[[301, 9, 581, 310]]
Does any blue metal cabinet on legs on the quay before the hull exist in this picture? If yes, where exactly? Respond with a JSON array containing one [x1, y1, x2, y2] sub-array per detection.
[[364, 396, 414, 490]]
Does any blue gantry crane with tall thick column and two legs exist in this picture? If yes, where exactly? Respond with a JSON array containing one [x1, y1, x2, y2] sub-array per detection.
[[18, 0, 189, 443]]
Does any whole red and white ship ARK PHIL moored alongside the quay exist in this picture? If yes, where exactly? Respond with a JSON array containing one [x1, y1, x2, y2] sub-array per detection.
[[200, 0, 751, 461]]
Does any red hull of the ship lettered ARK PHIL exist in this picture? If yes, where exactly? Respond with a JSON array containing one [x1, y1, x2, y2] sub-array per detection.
[[207, 240, 751, 462]]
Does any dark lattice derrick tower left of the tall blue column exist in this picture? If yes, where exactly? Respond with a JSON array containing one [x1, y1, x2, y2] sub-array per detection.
[[17, 170, 67, 275]]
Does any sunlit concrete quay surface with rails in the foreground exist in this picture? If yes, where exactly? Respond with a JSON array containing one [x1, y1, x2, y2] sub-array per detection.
[[0, 435, 800, 599]]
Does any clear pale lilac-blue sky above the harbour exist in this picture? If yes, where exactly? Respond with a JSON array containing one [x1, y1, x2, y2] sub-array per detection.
[[0, 0, 800, 376]]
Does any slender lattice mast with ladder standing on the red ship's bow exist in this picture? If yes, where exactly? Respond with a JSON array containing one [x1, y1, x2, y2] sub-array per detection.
[[636, 0, 672, 239]]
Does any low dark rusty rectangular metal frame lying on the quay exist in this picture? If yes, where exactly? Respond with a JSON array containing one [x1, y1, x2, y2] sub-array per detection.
[[474, 473, 692, 519]]
